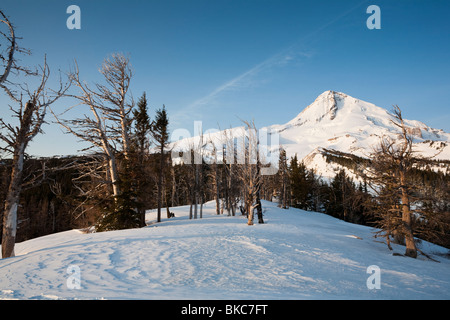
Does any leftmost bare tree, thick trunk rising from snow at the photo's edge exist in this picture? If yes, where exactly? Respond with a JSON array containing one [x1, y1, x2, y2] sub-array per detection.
[[0, 60, 70, 258]]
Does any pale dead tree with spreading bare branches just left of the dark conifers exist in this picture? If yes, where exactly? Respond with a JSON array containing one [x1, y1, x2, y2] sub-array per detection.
[[53, 55, 133, 199]]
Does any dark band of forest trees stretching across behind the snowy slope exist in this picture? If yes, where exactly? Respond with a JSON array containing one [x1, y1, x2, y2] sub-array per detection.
[[0, 102, 450, 254]]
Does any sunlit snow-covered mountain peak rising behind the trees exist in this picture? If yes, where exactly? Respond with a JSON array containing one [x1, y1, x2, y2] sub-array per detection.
[[174, 91, 450, 177]]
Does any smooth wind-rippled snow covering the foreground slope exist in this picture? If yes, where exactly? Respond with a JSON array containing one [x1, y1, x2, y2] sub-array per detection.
[[0, 201, 450, 300]]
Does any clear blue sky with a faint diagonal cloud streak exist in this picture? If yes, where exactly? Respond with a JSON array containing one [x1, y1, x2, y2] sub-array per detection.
[[0, 0, 450, 155]]
